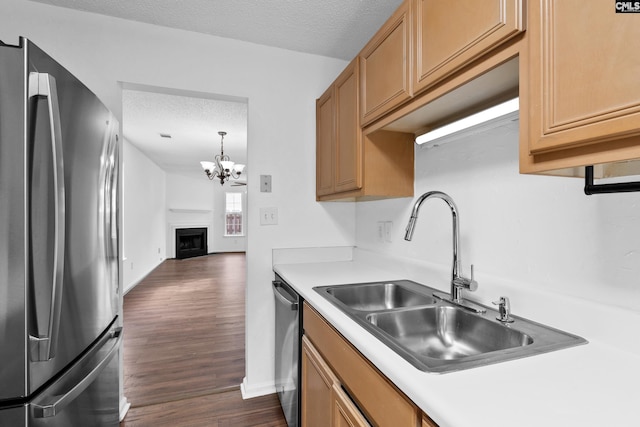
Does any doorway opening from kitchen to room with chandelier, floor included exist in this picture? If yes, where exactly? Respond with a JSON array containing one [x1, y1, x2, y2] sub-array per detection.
[[121, 83, 251, 418]]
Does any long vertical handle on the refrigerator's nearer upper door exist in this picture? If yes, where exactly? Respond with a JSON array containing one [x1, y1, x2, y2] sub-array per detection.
[[29, 72, 66, 361]]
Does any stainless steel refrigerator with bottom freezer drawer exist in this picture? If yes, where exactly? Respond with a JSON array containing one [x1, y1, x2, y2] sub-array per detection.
[[0, 38, 121, 427]]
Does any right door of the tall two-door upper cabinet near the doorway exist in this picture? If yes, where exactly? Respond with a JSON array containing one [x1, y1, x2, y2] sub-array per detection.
[[334, 57, 362, 192]]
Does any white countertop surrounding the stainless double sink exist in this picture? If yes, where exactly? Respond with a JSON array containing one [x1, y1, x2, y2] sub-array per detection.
[[274, 261, 640, 427]]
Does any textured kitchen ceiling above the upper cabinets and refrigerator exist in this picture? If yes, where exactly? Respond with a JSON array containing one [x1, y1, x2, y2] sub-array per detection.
[[33, 0, 402, 60]]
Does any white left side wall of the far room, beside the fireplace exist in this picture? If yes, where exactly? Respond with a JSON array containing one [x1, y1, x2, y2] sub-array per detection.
[[122, 139, 167, 292]]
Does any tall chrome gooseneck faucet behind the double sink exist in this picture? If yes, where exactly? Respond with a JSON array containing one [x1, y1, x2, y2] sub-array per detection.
[[404, 191, 486, 312]]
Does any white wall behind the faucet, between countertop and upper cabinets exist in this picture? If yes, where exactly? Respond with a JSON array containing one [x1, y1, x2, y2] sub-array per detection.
[[356, 122, 640, 311]]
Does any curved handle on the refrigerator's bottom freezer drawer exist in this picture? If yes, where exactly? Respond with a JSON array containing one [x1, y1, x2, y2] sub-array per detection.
[[32, 327, 122, 418]]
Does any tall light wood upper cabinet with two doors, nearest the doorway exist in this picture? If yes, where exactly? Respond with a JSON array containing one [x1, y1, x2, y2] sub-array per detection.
[[316, 57, 414, 201]]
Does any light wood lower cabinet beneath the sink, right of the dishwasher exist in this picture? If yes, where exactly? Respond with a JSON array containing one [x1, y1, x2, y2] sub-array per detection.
[[302, 303, 437, 427]]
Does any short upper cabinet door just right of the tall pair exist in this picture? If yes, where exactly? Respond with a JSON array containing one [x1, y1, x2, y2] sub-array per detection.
[[360, 0, 411, 126]]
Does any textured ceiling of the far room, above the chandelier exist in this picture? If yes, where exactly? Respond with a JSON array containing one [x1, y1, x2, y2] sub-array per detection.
[[122, 90, 250, 179]]
